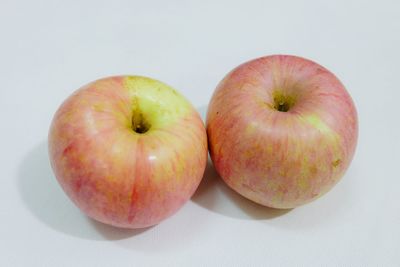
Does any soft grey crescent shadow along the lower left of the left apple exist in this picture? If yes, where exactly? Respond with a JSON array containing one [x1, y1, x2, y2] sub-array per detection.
[[17, 142, 148, 240]]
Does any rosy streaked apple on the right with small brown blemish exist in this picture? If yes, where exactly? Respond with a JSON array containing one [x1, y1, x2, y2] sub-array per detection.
[[206, 55, 358, 209]]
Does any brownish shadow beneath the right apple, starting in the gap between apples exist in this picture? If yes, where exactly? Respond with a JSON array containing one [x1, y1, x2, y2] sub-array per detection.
[[192, 159, 291, 220]]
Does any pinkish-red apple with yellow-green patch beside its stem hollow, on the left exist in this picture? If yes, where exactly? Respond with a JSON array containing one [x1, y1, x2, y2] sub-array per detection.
[[48, 76, 208, 228]]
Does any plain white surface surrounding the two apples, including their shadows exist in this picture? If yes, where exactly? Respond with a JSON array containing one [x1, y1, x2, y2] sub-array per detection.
[[0, 0, 400, 266]]
